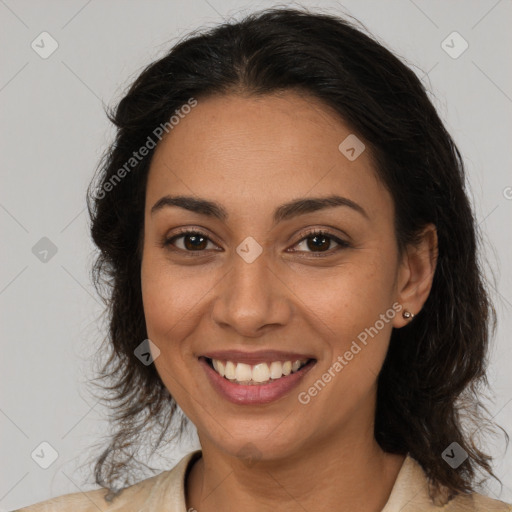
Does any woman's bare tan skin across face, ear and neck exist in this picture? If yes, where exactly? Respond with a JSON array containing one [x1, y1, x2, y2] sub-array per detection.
[[141, 91, 437, 512]]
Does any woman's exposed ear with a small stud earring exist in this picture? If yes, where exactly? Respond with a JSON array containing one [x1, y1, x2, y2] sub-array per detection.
[[393, 224, 438, 328]]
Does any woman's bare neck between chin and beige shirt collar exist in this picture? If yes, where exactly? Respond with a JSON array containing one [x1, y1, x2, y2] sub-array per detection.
[[186, 428, 405, 512]]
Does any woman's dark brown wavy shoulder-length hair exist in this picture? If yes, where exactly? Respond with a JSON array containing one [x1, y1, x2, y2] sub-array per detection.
[[87, 4, 509, 500]]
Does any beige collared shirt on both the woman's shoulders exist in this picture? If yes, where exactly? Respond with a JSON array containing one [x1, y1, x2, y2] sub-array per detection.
[[13, 450, 512, 512]]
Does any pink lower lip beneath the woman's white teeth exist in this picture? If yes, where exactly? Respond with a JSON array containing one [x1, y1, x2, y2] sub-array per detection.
[[199, 357, 316, 405]]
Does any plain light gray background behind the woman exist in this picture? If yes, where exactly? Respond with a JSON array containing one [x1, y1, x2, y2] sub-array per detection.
[[0, 0, 512, 511]]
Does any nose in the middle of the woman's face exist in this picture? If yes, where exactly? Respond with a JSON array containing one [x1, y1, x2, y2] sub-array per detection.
[[212, 251, 293, 337]]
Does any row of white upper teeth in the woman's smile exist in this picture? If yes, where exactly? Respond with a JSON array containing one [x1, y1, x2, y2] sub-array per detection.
[[207, 359, 308, 383]]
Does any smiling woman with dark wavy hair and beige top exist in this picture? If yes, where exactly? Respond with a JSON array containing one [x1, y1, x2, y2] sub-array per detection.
[[14, 5, 512, 512]]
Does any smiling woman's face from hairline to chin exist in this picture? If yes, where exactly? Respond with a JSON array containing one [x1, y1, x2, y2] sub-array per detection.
[[141, 92, 428, 458]]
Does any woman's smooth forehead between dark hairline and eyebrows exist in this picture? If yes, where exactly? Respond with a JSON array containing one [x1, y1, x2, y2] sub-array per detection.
[[146, 92, 391, 221]]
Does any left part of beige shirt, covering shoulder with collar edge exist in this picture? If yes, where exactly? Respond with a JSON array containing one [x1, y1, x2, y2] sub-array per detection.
[[12, 451, 201, 512]]
